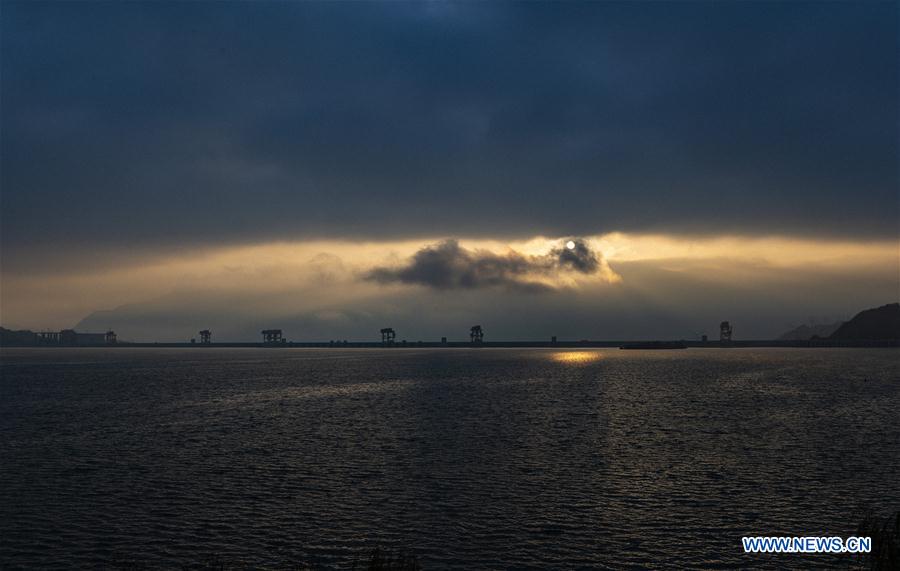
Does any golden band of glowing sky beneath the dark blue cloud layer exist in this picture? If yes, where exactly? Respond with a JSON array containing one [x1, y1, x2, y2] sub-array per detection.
[[2, 233, 898, 328]]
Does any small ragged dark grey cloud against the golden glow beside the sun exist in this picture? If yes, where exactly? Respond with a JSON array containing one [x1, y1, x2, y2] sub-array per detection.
[[365, 240, 600, 293]]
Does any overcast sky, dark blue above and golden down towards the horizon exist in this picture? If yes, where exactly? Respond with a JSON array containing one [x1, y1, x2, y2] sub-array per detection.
[[0, 2, 900, 338]]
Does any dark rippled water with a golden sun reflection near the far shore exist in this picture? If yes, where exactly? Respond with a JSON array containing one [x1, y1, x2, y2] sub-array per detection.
[[0, 348, 900, 569]]
